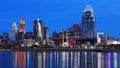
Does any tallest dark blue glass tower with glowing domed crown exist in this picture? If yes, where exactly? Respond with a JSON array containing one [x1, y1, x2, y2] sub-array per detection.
[[81, 5, 95, 39]]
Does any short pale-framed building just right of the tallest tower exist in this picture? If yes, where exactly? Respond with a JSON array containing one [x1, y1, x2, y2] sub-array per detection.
[[97, 32, 107, 45]]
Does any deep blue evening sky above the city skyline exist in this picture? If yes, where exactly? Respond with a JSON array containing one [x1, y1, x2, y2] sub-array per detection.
[[0, 0, 120, 38]]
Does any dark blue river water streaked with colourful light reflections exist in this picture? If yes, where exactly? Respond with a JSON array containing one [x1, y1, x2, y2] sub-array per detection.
[[0, 52, 120, 68]]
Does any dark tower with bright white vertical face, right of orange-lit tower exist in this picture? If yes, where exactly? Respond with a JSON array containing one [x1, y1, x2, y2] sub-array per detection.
[[33, 19, 44, 41]]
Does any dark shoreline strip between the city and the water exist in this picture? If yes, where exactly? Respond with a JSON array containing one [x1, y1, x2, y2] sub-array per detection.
[[0, 48, 120, 52]]
